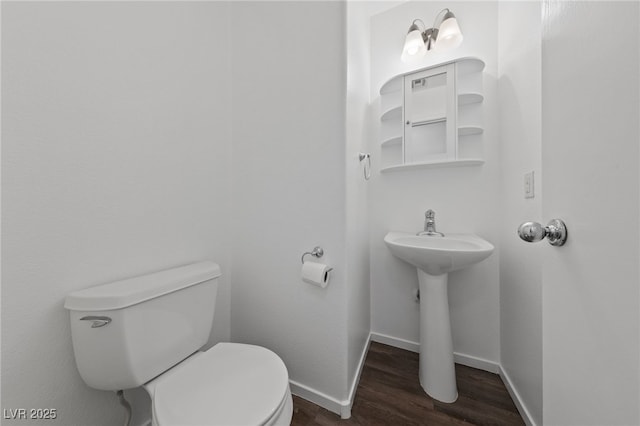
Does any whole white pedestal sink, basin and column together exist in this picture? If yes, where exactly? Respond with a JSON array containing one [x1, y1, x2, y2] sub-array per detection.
[[384, 232, 494, 402]]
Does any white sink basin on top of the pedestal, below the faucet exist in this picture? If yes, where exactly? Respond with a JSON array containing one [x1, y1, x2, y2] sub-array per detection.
[[384, 232, 494, 275]]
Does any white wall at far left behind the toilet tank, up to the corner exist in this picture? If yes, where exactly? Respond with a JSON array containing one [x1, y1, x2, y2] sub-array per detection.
[[2, 2, 230, 425]]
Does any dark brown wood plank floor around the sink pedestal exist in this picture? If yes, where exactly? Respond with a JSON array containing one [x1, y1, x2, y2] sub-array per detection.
[[291, 342, 524, 426]]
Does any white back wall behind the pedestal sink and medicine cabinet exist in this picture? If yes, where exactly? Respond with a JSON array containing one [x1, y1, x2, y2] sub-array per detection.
[[370, 2, 501, 363]]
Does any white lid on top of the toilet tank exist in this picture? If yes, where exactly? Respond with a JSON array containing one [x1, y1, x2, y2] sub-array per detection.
[[64, 261, 222, 311]]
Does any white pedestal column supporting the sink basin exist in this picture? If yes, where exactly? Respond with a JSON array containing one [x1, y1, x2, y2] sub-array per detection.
[[418, 269, 458, 402]]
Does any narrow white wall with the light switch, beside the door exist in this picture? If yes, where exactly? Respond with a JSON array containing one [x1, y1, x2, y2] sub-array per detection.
[[498, 1, 548, 424]]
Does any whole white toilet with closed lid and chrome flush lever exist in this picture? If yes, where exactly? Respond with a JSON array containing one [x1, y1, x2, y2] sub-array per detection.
[[64, 262, 293, 426]]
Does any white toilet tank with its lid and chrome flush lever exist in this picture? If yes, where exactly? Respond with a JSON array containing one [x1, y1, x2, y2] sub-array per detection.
[[64, 261, 221, 390]]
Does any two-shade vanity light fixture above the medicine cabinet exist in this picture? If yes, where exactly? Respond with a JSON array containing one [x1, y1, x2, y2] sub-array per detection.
[[402, 9, 463, 62]]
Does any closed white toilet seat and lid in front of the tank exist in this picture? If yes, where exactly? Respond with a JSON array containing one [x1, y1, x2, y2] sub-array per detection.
[[152, 343, 292, 426]]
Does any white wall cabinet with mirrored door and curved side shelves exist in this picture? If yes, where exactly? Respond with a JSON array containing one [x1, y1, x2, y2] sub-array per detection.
[[380, 58, 485, 173]]
